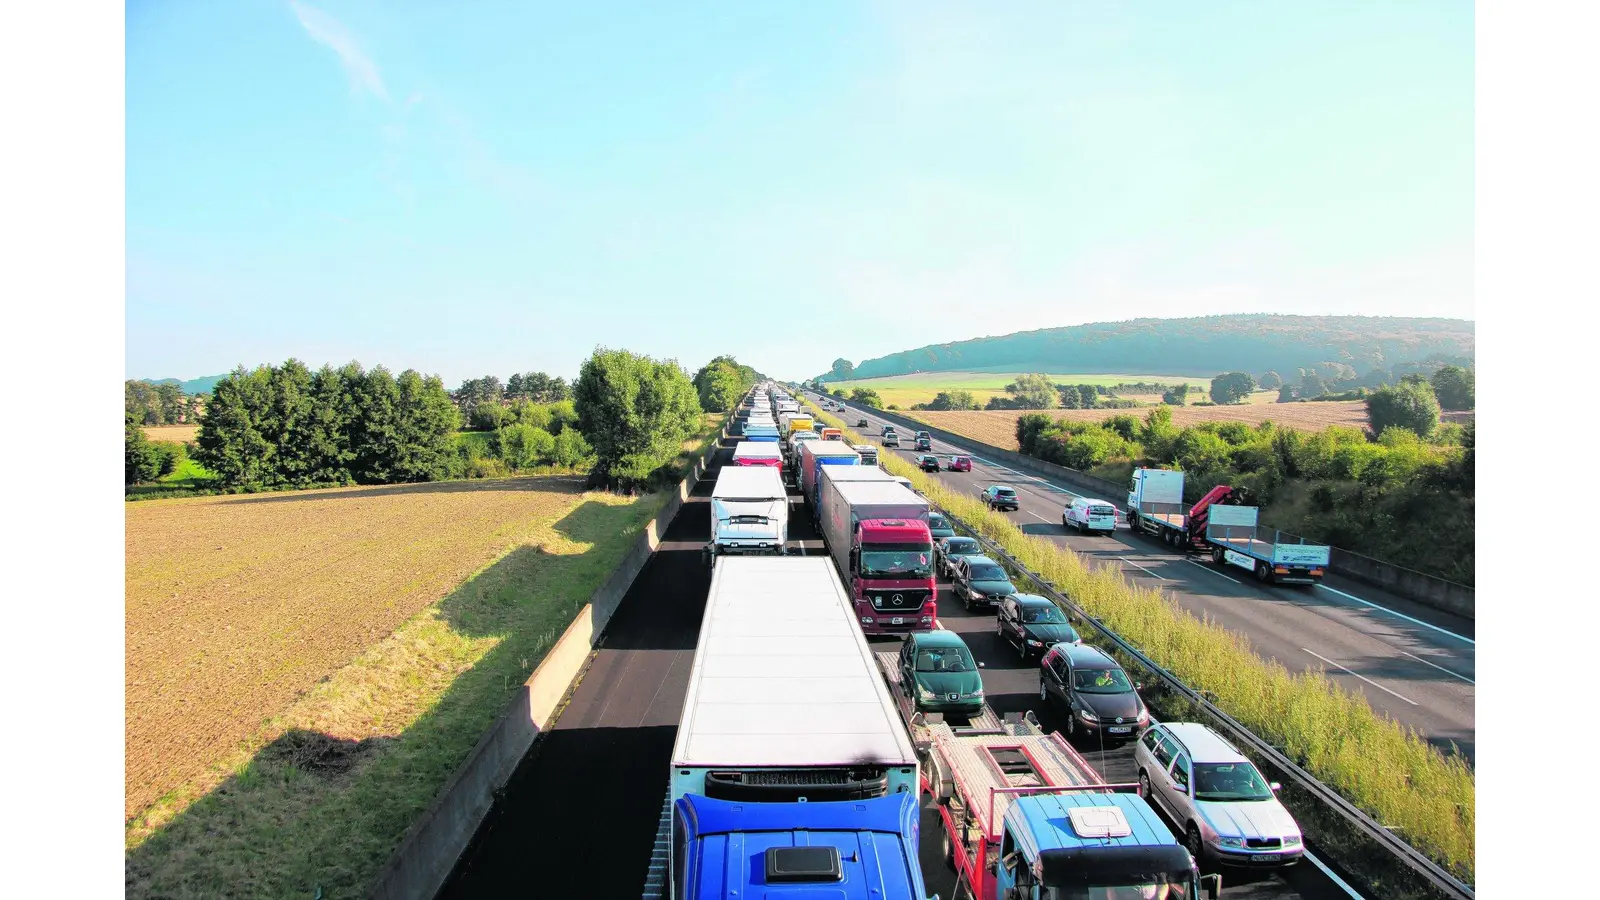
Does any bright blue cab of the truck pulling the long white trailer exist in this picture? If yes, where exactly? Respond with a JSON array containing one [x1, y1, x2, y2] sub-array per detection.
[[669, 793, 938, 900]]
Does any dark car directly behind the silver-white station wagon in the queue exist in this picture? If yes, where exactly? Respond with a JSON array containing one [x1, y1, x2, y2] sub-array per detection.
[[1038, 644, 1150, 740]]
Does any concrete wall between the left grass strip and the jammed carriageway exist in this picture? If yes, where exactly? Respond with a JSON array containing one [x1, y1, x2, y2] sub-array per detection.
[[371, 424, 728, 900]]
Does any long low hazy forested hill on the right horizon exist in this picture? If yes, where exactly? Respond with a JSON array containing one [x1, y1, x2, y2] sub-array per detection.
[[822, 314, 1475, 381]]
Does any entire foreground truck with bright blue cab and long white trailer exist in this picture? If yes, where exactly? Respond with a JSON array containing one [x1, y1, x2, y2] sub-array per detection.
[[643, 556, 926, 900]]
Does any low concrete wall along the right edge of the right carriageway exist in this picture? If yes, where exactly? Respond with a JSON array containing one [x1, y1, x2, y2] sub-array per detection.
[[875, 410, 1477, 618]]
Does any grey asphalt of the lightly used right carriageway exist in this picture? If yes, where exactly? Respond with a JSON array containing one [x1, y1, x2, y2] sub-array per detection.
[[808, 396, 1477, 762]]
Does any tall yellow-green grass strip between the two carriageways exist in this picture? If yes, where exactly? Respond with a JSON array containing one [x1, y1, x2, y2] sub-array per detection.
[[813, 398, 1477, 882]]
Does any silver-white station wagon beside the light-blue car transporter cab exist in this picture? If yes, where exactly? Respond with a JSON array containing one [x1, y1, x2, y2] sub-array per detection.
[[1133, 722, 1306, 868]]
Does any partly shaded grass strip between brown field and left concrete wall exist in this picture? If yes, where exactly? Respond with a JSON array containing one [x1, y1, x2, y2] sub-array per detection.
[[125, 416, 722, 898]]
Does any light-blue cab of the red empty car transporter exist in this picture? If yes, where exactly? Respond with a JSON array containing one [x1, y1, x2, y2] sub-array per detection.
[[982, 793, 1222, 900]]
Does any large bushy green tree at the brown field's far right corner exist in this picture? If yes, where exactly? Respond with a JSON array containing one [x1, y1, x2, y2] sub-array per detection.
[[573, 348, 701, 487]]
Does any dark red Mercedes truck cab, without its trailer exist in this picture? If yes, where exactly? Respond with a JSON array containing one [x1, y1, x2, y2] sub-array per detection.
[[850, 519, 939, 634]]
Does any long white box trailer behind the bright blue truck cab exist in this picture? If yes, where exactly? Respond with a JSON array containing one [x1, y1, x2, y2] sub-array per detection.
[[670, 556, 918, 801]]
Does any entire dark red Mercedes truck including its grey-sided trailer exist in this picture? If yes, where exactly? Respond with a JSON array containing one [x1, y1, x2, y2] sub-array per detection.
[[818, 480, 939, 634]]
